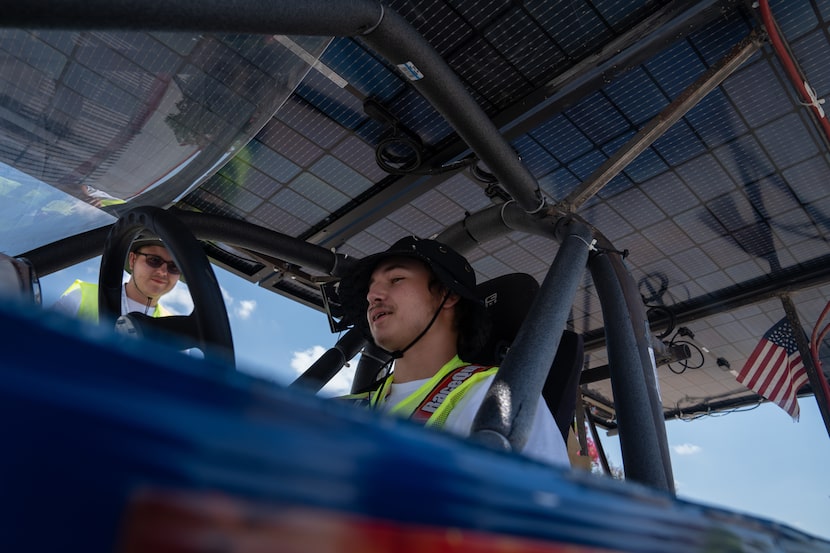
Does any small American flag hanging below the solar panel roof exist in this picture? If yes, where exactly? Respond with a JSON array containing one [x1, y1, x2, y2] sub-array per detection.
[[738, 317, 807, 420]]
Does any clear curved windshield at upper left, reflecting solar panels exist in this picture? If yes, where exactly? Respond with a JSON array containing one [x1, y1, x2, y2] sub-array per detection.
[[0, 30, 329, 255]]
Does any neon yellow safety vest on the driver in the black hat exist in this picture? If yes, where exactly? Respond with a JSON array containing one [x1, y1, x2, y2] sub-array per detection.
[[340, 355, 498, 428]]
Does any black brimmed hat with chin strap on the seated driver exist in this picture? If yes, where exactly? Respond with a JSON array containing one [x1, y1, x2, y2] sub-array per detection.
[[338, 236, 481, 326]]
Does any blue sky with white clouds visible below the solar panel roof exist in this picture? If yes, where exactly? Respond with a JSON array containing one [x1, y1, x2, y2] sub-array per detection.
[[41, 258, 830, 540]]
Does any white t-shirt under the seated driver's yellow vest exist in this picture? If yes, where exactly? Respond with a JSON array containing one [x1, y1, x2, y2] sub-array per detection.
[[381, 375, 570, 467]]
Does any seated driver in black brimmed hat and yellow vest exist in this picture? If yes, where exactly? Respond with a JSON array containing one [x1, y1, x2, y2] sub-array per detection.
[[340, 236, 569, 466]]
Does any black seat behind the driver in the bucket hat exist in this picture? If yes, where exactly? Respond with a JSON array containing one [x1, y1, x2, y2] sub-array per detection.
[[469, 273, 584, 443]]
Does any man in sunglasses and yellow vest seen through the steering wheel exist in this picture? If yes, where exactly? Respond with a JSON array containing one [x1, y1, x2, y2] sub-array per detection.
[[52, 236, 181, 323]]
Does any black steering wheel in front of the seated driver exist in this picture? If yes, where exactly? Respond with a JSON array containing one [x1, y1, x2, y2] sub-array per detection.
[[98, 206, 234, 368]]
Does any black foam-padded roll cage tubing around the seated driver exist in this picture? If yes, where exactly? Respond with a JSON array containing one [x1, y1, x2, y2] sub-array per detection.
[[13, 0, 674, 493]]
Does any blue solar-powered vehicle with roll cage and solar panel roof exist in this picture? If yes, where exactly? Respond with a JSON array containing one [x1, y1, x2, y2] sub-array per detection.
[[0, 0, 830, 552]]
